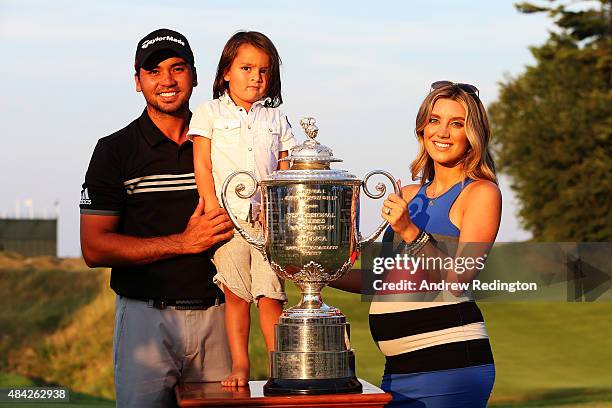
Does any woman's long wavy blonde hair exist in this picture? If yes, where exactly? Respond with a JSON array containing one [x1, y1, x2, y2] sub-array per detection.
[[410, 85, 497, 184]]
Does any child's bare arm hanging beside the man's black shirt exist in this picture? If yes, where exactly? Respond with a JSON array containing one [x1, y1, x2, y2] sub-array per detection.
[[193, 136, 220, 213]]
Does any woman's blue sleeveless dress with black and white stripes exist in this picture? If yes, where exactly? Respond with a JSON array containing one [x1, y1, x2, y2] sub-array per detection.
[[369, 180, 495, 408]]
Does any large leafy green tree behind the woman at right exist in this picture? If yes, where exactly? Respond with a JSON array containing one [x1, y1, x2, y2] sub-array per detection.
[[489, 0, 612, 242]]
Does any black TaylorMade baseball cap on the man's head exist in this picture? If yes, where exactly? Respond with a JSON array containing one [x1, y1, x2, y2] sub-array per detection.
[[134, 28, 194, 73]]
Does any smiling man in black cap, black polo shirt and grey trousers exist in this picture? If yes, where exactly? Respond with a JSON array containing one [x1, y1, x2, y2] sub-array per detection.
[[80, 29, 233, 407]]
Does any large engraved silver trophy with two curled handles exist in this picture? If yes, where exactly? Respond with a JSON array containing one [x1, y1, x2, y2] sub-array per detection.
[[221, 118, 399, 395]]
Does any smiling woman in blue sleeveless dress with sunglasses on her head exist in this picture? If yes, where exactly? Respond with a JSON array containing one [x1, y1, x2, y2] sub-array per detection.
[[334, 81, 501, 408]]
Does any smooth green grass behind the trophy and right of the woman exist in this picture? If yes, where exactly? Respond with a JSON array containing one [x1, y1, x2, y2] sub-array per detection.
[[250, 284, 612, 407]]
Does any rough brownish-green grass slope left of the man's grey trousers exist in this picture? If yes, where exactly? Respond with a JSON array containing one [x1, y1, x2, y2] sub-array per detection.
[[0, 267, 114, 398]]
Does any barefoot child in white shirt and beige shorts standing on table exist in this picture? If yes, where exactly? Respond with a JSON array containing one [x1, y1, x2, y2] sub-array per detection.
[[188, 31, 297, 386]]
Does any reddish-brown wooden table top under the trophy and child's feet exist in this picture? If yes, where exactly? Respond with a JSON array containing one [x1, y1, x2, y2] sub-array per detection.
[[174, 379, 391, 407]]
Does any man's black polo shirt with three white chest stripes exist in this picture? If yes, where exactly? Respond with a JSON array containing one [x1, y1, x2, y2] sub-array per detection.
[[80, 109, 221, 300]]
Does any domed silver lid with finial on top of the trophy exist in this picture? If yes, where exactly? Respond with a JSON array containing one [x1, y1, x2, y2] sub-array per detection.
[[262, 118, 357, 183]]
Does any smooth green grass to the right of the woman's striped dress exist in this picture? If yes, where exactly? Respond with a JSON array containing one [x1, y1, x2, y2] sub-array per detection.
[[480, 302, 612, 401]]
